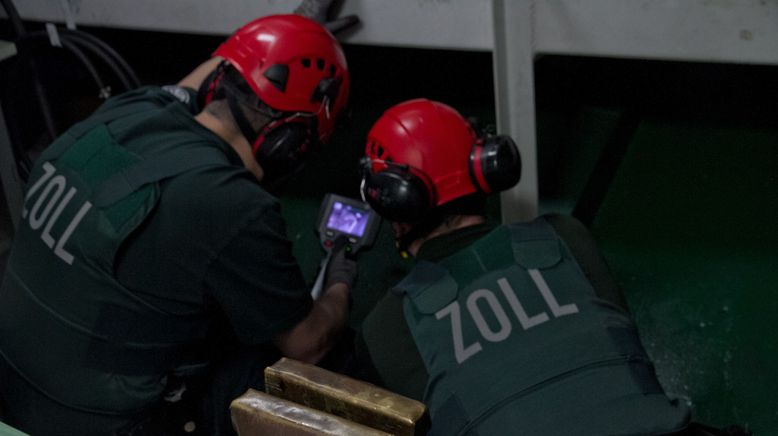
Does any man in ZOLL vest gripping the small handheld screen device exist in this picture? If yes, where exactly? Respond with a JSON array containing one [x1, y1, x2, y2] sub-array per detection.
[[0, 2, 356, 435]]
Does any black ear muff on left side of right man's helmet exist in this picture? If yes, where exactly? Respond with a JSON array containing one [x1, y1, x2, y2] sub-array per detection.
[[362, 167, 433, 223]]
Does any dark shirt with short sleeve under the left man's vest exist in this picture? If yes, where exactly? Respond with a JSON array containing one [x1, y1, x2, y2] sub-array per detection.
[[112, 88, 311, 344]]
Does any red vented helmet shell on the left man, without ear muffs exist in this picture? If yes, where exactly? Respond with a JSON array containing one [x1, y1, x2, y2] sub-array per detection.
[[214, 14, 350, 142]]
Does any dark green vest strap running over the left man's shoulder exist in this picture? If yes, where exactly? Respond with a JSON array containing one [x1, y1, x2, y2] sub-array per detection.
[[92, 147, 226, 207]]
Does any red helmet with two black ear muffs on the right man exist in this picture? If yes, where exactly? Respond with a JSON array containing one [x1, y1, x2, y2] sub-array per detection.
[[362, 99, 521, 222]]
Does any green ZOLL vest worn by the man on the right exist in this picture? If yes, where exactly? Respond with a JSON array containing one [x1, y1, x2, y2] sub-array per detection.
[[395, 218, 689, 436]]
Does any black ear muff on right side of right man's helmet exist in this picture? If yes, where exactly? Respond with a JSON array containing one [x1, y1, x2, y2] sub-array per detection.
[[470, 135, 521, 193]]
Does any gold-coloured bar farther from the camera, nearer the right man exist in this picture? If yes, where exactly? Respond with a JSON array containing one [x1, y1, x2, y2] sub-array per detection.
[[265, 358, 428, 436]]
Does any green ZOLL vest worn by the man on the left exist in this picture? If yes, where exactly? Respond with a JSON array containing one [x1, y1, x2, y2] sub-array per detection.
[[0, 103, 227, 415]]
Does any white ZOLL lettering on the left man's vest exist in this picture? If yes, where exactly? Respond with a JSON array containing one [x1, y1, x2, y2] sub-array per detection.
[[22, 162, 92, 265]]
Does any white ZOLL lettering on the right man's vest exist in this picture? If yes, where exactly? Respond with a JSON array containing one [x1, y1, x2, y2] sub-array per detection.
[[435, 269, 579, 364]]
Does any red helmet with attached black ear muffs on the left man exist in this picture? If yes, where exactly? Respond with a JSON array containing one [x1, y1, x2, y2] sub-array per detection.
[[198, 14, 350, 185]]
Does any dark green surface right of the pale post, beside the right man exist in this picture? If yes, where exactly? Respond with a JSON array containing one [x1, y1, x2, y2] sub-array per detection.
[[536, 58, 778, 435]]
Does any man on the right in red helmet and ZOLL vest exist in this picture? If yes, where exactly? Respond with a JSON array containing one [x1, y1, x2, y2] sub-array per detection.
[[357, 99, 689, 436]]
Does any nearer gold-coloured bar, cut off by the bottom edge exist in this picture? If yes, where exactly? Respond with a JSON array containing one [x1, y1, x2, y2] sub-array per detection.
[[230, 389, 390, 436]]
